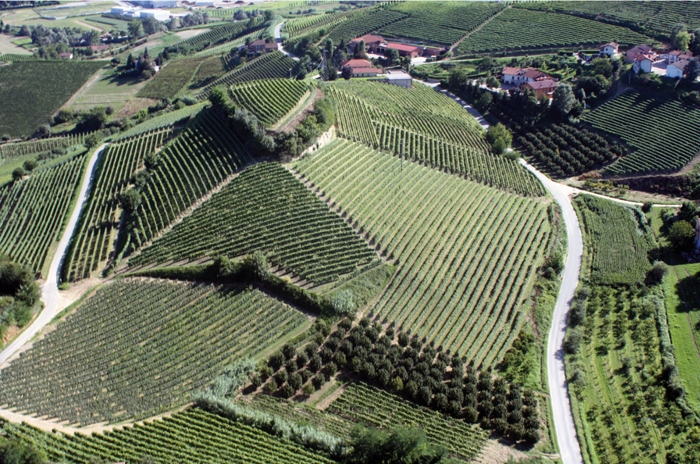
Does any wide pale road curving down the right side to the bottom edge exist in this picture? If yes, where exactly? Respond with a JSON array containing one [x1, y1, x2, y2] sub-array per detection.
[[520, 159, 583, 464]]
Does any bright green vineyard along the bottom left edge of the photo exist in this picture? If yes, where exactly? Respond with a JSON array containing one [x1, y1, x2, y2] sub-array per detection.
[[0, 409, 335, 464]]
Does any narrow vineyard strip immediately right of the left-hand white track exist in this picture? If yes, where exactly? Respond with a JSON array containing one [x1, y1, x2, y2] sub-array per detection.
[[61, 128, 172, 281]]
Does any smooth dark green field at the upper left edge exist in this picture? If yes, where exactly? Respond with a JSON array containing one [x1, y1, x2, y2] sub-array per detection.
[[0, 61, 105, 136]]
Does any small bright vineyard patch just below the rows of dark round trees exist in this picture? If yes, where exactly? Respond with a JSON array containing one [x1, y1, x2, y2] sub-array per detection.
[[329, 383, 486, 459]]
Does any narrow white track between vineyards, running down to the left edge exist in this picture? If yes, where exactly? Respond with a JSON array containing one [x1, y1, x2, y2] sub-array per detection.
[[0, 143, 107, 366]]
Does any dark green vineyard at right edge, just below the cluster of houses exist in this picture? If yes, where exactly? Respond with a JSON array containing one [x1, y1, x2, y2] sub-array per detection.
[[583, 91, 700, 175]]
